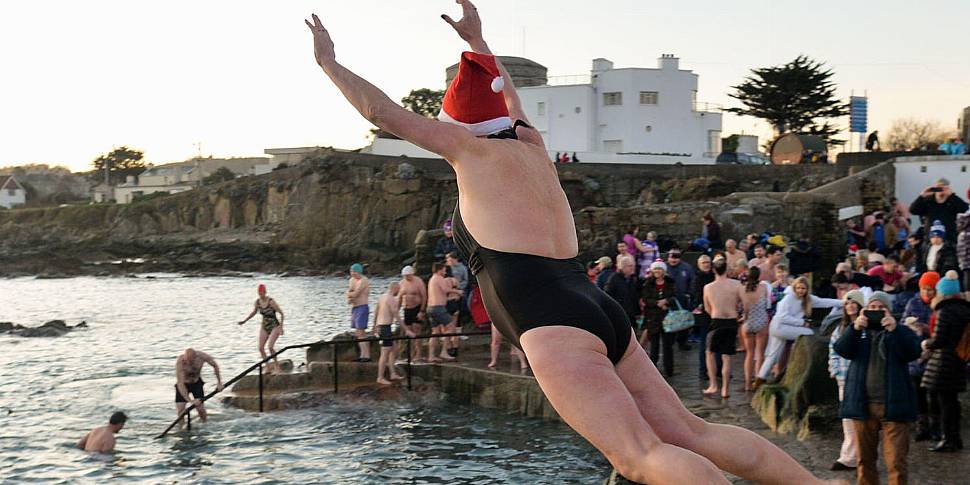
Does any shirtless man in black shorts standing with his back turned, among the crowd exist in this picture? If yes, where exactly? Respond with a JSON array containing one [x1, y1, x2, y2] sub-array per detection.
[[704, 256, 744, 398]]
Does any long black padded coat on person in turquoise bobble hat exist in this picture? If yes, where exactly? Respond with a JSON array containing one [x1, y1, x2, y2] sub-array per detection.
[[920, 299, 970, 392]]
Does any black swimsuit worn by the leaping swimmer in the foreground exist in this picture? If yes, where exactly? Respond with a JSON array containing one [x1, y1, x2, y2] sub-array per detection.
[[452, 201, 633, 365]]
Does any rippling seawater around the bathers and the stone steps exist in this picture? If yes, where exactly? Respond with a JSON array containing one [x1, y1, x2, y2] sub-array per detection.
[[0, 274, 608, 484]]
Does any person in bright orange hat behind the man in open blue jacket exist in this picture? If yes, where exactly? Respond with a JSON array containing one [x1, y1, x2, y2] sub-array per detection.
[[903, 271, 940, 441]]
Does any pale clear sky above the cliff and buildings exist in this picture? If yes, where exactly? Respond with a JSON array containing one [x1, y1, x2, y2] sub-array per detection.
[[0, 0, 970, 171]]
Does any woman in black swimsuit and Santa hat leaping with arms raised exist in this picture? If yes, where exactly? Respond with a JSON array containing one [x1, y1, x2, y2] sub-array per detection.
[[306, 0, 840, 484]]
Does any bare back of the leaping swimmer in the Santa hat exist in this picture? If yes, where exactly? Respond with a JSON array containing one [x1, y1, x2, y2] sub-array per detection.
[[452, 138, 579, 259]]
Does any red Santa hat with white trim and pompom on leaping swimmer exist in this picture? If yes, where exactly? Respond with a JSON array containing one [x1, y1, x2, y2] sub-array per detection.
[[438, 52, 512, 136]]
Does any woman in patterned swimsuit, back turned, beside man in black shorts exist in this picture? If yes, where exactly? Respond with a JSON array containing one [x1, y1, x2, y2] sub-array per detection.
[[741, 266, 771, 391]]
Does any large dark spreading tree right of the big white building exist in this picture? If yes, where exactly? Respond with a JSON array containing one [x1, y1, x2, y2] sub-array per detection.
[[725, 55, 849, 145]]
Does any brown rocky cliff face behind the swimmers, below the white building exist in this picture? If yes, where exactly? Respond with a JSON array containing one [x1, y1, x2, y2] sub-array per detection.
[[0, 151, 868, 275]]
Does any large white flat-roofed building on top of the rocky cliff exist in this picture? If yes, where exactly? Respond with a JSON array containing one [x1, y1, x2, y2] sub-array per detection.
[[518, 54, 721, 163]]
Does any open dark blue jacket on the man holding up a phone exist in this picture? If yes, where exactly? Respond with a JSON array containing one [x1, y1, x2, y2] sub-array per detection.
[[834, 324, 920, 422]]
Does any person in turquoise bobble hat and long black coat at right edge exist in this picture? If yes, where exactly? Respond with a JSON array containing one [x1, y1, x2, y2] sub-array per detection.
[[922, 271, 970, 452]]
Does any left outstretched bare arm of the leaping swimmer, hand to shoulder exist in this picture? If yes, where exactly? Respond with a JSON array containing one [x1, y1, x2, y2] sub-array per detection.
[[305, 14, 480, 162]]
